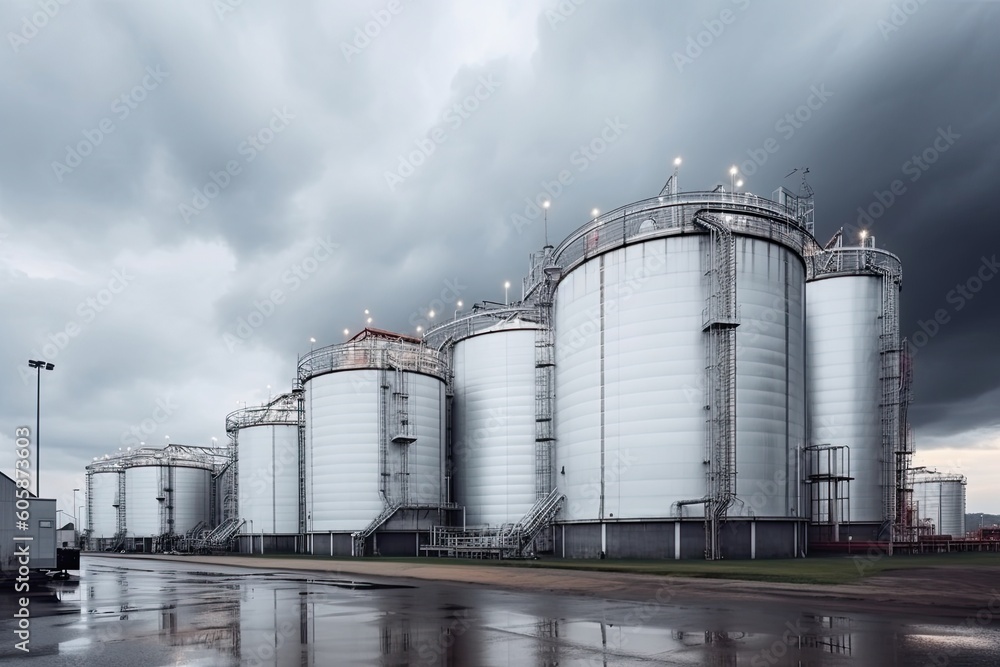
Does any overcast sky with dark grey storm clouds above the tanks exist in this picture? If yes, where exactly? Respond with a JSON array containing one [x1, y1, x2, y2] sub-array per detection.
[[0, 0, 1000, 514]]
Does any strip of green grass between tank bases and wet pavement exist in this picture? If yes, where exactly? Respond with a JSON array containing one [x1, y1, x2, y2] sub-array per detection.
[[213, 553, 1000, 584]]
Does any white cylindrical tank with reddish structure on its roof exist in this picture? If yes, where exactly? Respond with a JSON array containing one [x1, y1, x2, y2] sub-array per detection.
[[299, 330, 447, 532]]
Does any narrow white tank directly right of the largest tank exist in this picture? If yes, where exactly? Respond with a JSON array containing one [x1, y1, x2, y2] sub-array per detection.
[[806, 239, 901, 538]]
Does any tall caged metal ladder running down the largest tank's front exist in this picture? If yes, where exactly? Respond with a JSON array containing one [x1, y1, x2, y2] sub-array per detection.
[[693, 212, 740, 560]]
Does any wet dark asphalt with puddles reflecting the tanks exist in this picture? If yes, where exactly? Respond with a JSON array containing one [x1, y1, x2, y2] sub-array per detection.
[[0, 556, 1000, 667]]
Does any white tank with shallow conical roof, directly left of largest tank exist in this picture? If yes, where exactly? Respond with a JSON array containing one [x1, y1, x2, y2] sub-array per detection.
[[442, 308, 552, 525]]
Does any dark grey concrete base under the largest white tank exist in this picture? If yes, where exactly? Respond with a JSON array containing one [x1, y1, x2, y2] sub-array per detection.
[[552, 518, 807, 560]]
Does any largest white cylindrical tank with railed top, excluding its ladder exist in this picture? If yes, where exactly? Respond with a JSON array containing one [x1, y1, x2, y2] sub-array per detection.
[[554, 198, 806, 536]]
